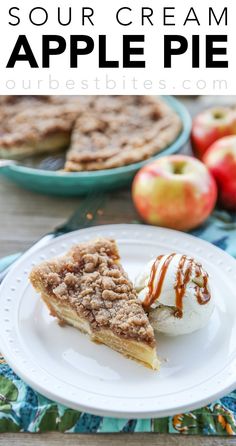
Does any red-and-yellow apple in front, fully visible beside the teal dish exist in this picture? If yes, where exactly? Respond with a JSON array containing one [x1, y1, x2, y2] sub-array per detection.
[[132, 155, 217, 231]]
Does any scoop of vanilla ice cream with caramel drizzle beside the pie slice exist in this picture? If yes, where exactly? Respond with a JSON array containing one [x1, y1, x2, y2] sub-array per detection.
[[135, 253, 214, 336]]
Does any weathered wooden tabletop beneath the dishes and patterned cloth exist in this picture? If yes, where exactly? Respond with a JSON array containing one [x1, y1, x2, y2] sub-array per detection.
[[0, 97, 236, 446]]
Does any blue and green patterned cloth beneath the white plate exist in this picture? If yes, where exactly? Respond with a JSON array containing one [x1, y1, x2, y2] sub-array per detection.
[[0, 211, 236, 435]]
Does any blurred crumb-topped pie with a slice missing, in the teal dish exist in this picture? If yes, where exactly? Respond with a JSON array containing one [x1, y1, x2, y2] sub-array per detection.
[[0, 96, 182, 172]]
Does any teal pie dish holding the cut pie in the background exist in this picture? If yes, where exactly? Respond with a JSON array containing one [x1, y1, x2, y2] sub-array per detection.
[[0, 96, 191, 196]]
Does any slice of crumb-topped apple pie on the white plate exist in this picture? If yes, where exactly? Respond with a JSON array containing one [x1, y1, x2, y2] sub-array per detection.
[[30, 239, 158, 369]]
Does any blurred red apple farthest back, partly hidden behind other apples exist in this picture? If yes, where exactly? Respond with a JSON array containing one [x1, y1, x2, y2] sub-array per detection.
[[191, 107, 236, 159]]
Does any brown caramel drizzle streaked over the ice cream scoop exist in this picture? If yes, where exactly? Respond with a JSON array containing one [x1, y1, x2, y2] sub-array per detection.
[[143, 253, 211, 318]]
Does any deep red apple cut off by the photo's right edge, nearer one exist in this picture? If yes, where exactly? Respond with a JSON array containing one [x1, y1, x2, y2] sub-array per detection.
[[203, 136, 236, 211]]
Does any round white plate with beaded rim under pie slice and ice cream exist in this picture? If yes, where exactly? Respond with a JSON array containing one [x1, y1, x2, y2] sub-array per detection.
[[0, 225, 236, 418]]
